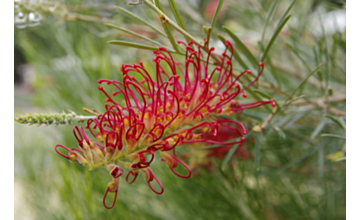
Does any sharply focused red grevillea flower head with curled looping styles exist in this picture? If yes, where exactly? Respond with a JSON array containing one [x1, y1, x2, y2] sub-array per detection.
[[55, 41, 274, 208]]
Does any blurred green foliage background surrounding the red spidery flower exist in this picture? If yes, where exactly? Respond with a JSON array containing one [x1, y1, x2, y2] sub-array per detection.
[[14, 0, 346, 220]]
